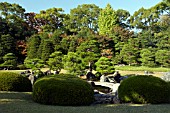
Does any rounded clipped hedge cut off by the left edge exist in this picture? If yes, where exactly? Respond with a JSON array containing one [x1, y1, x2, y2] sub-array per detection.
[[0, 72, 32, 92]]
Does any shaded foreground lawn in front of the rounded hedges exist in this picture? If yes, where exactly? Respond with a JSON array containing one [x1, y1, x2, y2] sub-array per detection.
[[0, 92, 170, 113]]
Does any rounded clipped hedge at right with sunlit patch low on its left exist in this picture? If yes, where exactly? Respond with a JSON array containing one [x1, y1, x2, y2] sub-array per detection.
[[118, 75, 169, 104]]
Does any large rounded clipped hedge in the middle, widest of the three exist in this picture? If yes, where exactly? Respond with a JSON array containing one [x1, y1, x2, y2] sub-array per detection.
[[33, 75, 94, 106]]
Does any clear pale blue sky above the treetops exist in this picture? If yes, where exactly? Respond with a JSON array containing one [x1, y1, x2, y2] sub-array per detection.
[[0, 0, 162, 14]]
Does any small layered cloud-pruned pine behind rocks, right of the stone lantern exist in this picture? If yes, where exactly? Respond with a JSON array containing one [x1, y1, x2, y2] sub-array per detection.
[[95, 57, 115, 74]]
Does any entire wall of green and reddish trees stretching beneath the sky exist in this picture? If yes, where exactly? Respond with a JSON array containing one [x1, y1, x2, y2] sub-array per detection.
[[0, 0, 170, 72]]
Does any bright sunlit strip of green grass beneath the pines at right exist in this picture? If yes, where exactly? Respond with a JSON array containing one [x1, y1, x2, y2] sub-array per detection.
[[115, 66, 170, 72]]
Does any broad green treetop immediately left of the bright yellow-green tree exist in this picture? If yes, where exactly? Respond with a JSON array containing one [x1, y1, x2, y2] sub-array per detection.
[[65, 4, 101, 33]]
